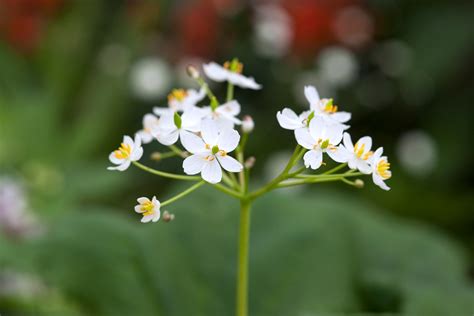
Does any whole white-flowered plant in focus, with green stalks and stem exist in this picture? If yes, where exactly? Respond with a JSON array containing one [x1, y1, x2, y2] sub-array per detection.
[[109, 59, 391, 316]]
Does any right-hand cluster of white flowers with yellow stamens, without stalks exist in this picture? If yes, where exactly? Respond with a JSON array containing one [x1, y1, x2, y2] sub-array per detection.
[[277, 86, 392, 190]]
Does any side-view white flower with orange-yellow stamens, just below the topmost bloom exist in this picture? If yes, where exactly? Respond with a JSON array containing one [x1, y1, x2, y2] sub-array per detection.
[[153, 88, 206, 116]]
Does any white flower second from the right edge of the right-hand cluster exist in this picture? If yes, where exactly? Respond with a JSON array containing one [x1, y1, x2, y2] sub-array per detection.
[[333, 133, 374, 174]]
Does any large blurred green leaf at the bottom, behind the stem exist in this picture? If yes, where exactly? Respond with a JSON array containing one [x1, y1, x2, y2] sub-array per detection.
[[3, 189, 474, 315]]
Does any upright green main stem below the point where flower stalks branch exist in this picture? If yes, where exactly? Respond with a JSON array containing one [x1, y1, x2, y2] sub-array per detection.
[[236, 200, 251, 316]]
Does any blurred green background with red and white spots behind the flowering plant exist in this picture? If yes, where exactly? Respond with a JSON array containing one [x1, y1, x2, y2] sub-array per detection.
[[0, 0, 474, 316]]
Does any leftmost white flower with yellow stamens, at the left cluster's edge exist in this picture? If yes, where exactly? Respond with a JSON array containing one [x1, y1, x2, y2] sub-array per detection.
[[107, 135, 143, 171]]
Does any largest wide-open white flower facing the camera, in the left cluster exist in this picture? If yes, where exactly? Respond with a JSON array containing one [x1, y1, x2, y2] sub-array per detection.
[[181, 119, 243, 183]]
